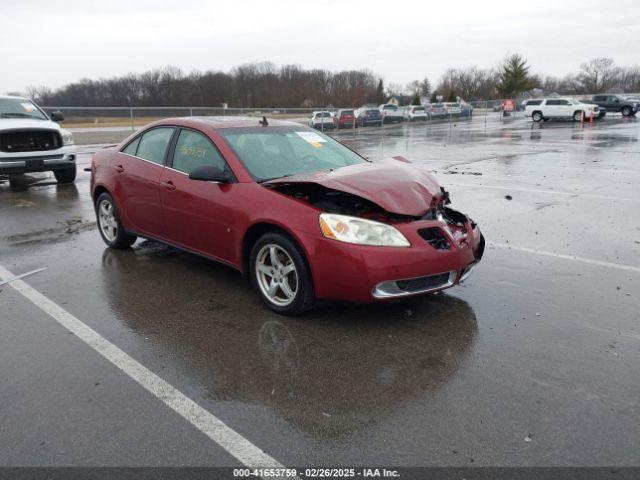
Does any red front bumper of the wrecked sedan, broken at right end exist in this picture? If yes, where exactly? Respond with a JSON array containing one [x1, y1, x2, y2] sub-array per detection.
[[302, 213, 484, 302]]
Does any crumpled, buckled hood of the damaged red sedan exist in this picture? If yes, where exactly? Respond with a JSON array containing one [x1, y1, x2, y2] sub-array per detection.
[[264, 161, 444, 217]]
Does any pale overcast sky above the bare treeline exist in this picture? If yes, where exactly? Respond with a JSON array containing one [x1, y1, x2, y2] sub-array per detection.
[[0, 0, 640, 93]]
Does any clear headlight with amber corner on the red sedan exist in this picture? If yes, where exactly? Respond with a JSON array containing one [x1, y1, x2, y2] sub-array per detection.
[[320, 213, 411, 247]]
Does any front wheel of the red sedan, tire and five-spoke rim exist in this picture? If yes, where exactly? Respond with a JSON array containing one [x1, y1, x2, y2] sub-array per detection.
[[249, 232, 316, 316]]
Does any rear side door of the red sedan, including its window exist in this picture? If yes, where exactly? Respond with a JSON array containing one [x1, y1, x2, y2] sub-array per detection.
[[114, 127, 175, 237]]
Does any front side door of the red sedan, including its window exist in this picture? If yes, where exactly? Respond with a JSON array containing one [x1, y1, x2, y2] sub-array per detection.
[[160, 128, 238, 262]]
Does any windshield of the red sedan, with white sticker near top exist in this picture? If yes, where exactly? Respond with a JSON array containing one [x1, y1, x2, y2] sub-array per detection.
[[220, 127, 366, 182]]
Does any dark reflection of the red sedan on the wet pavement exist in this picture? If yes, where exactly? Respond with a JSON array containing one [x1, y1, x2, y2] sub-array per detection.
[[102, 241, 477, 438]]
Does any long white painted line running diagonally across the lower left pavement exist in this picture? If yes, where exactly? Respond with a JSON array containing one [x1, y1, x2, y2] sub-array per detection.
[[0, 265, 292, 478]]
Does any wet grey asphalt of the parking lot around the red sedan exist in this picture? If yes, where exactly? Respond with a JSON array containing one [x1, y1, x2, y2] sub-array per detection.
[[0, 115, 640, 466]]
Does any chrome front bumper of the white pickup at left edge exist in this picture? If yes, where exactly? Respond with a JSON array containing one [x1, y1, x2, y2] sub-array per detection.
[[0, 145, 76, 175]]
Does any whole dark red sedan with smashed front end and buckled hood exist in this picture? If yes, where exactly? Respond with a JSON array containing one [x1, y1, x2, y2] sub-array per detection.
[[91, 117, 484, 315]]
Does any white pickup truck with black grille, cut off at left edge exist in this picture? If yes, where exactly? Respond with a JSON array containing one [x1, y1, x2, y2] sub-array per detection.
[[0, 96, 76, 183]]
